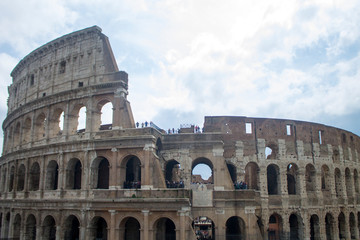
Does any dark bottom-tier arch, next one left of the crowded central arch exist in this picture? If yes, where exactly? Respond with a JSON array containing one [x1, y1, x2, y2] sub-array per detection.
[[153, 217, 176, 240]]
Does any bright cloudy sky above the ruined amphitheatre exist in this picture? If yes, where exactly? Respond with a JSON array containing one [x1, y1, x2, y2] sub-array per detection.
[[0, 0, 360, 153]]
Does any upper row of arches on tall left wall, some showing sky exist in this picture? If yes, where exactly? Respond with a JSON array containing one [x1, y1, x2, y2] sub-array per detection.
[[4, 98, 113, 150]]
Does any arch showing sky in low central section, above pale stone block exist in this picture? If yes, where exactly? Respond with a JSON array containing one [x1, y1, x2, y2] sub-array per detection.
[[191, 158, 214, 184]]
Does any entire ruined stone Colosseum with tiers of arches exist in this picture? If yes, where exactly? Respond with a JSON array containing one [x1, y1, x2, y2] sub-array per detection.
[[0, 26, 360, 240]]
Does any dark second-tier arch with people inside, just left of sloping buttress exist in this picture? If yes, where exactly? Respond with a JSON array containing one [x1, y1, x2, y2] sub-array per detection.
[[124, 156, 141, 189]]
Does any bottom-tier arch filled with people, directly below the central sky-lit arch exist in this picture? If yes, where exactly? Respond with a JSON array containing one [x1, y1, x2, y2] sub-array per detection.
[[192, 216, 216, 240]]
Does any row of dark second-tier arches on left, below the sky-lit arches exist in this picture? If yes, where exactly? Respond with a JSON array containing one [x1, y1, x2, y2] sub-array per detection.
[[1, 155, 141, 192]]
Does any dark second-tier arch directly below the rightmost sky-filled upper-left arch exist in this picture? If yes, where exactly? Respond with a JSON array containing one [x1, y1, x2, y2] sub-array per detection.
[[91, 157, 110, 189]]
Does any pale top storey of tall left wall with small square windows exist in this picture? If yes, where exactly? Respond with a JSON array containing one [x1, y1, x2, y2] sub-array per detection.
[[8, 26, 118, 113]]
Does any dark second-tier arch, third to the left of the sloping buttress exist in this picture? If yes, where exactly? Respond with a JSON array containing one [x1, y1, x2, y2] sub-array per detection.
[[66, 158, 82, 189]]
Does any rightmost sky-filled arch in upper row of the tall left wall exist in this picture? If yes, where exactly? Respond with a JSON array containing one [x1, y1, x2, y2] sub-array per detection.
[[97, 99, 113, 130]]
